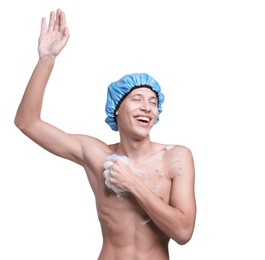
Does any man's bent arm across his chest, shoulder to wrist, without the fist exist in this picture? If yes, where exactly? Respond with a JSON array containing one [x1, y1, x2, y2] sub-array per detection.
[[130, 149, 196, 245]]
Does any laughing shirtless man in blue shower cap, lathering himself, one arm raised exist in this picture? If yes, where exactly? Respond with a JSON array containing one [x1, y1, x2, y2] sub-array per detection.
[[15, 9, 196, 260]]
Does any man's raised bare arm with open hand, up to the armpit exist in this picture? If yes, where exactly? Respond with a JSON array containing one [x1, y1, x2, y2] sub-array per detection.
[[15, 9, 85, 164]]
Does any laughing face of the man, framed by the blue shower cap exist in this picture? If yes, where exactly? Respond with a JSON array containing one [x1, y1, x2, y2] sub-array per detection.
[[116, 87, 158, 135]]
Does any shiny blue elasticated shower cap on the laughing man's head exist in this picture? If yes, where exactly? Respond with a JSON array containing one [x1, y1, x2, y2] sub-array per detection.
[[105, 73, 165, 131]]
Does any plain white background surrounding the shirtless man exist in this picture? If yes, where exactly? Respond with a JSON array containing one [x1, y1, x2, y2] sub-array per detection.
[[0, 0, 265, 260]]
